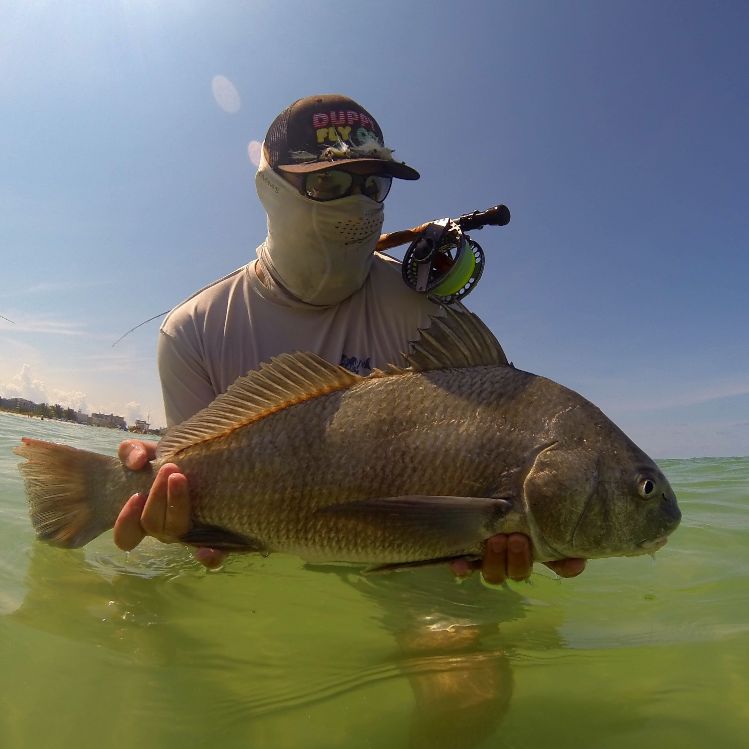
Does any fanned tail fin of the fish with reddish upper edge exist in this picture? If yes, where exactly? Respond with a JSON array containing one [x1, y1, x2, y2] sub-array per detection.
[[13, 437, 127, 549]]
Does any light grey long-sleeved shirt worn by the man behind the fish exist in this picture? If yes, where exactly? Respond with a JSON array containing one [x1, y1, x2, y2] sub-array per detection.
[[158, 254, 439, 426]]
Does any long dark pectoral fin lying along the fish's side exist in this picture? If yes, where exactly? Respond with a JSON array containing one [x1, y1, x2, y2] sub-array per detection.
[[319, 495, 513, 558]]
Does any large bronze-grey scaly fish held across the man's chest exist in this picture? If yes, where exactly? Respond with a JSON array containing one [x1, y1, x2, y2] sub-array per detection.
[[15, 308, 681, 570]]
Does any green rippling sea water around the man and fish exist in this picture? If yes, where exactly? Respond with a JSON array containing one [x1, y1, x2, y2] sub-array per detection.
[[0, 413, 749, 749]]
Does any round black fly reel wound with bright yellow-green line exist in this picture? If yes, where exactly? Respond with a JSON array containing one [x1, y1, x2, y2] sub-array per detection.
[[402, 218, 484, 304]]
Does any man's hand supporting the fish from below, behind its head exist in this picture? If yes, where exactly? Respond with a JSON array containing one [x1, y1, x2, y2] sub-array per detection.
[[450, 533, 585, 585]]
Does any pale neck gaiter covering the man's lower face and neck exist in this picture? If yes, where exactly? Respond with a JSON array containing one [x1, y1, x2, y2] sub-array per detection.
[[255, 160, 384, 306]]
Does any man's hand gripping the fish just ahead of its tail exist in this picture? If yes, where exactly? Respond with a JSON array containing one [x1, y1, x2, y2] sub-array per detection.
[[114, 440, 226, 567]]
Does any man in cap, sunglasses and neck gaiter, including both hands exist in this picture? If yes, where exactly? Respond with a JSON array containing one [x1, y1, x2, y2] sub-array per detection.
[[114, 94, 585, 584]]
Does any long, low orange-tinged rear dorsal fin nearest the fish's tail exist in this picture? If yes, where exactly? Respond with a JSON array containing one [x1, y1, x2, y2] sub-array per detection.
[[158, 353, 362, 460]]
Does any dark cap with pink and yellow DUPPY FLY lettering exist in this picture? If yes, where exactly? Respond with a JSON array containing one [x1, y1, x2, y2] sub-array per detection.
[[264, 94, 420, 179]]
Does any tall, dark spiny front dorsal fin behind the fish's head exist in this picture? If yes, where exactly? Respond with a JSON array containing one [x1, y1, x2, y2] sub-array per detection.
[[403, 307, 510, 371]]
